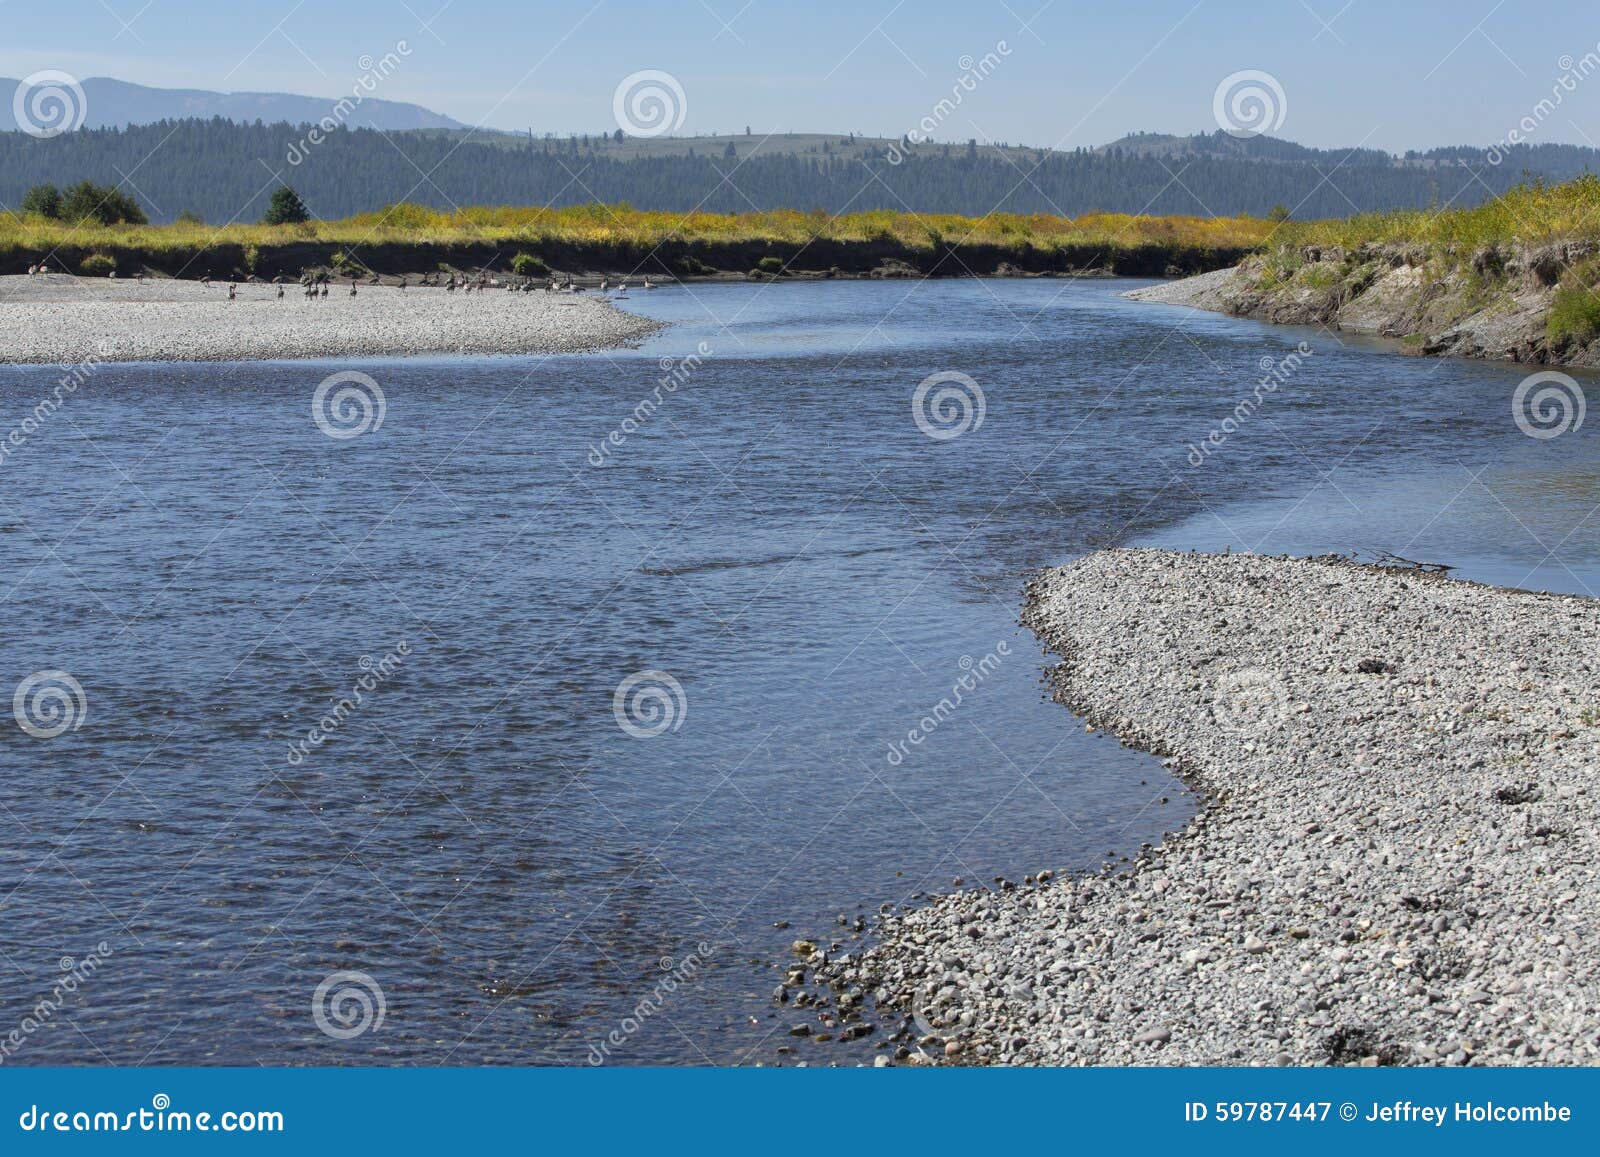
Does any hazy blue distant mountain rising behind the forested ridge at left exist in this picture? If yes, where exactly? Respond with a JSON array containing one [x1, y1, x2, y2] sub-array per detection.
[[0, 77, 464, 131]]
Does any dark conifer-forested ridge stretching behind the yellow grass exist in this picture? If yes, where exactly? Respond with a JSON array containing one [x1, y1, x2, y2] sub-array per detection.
[[0, 118, 1600, 224]]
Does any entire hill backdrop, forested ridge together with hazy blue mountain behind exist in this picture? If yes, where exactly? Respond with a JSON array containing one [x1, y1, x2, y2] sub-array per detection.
[[0, 77, 1600, 222]]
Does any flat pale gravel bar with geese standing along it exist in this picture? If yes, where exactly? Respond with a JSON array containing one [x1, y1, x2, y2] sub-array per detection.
[[0, 274, 661, 365]]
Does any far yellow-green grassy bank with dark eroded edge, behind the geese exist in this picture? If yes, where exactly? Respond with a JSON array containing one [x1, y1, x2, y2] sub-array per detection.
[[0, 205, 1272, 277]]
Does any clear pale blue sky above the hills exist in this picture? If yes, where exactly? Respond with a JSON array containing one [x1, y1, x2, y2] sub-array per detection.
[[0, 0, 1600, 150]]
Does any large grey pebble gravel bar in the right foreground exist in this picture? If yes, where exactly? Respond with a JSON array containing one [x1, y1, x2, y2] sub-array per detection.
[[812, 549, 1600, 1064]]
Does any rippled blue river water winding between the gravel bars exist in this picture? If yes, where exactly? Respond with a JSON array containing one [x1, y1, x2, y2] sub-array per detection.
[[0, 280, 1600, 1064]]
